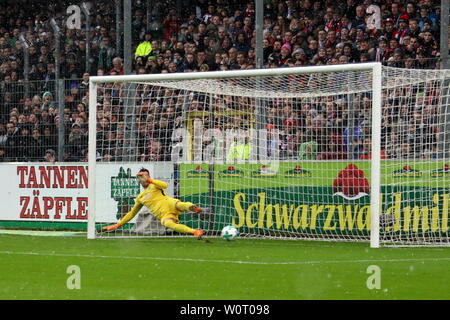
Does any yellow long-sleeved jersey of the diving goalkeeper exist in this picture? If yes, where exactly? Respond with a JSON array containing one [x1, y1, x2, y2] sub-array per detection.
[[119, 180, 181, 225]]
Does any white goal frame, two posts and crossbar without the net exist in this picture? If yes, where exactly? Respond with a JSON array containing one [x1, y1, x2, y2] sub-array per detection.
[[87, 62, 382, 248]]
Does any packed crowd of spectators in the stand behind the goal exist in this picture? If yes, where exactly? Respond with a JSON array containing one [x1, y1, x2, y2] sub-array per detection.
[[0, 0, 440, 161]]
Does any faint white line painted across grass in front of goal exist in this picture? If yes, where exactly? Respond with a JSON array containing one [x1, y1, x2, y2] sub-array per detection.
[[0, 251, 450, 265]]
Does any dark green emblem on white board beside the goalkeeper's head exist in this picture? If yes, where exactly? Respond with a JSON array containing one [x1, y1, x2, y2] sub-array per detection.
[[111, 167, 141, 219]]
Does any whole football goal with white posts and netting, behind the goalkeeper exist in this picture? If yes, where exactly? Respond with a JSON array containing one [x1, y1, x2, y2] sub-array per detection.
[[88, 63, 450, 247]]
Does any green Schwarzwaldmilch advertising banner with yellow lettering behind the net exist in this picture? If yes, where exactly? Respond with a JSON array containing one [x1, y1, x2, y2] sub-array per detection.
[[180, 161, 450, 237]]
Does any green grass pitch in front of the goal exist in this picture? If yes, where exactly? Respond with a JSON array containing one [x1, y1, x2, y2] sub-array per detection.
[[0, 234, 450, 300]]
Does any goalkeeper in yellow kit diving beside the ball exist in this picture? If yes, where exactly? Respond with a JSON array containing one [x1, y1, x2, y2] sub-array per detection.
[[102, 168, 204, 239]]
